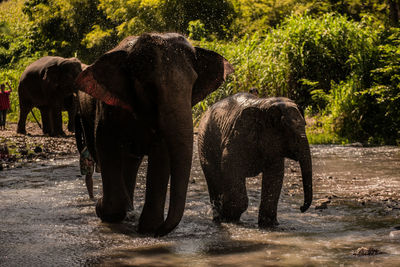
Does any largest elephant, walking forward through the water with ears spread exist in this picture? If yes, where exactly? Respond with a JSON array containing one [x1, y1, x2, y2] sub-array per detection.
[[76, 33, 233, 236]]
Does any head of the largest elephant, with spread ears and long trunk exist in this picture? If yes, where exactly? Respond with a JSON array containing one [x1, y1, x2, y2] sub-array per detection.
[[76, 33, 233, 235]]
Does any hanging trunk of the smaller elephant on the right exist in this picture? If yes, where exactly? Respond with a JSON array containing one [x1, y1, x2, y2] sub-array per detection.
[[299, 135, 313, 212]]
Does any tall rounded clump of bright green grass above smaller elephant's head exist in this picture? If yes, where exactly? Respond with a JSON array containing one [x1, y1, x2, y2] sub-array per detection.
[[270, 14, 378, 110]]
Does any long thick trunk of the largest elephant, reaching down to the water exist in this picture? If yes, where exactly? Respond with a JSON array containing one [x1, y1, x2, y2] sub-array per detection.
[[155, 103, 193, 236]]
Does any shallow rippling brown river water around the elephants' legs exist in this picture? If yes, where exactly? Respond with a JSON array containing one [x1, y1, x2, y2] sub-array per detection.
[[0, 143, 400, 266]]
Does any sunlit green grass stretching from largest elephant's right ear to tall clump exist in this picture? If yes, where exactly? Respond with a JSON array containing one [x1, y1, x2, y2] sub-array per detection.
[[195, 14, 379, 126]]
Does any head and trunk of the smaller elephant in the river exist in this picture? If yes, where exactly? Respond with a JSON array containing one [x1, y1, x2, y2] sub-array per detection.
[[242, 97, 313, 212]]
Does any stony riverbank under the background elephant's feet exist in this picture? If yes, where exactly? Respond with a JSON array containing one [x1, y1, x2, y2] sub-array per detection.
[[0, 122, 78, 170]]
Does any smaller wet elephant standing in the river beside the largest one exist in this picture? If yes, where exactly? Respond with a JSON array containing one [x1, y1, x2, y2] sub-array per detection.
[[198, 93, 312, 227]]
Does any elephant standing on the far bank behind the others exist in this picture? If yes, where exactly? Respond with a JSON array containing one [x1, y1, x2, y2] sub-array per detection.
[[17, 56, 86, 136]]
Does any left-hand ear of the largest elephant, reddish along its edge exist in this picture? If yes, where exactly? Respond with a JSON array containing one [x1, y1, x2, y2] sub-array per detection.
[[76, 50, 133, 112]]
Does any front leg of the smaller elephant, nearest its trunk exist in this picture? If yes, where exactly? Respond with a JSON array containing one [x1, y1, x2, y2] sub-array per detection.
[[258, 158, 285, 227]]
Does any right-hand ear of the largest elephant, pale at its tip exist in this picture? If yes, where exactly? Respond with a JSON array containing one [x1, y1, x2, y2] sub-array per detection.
[[192, 47, 234, 106]]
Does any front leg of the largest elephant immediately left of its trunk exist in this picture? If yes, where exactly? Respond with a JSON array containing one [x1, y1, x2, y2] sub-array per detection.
[[138, 142, 170, 233]]
